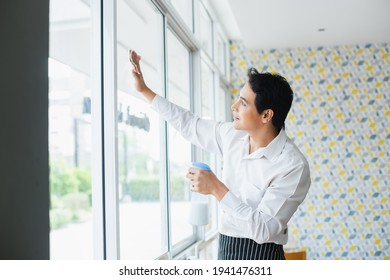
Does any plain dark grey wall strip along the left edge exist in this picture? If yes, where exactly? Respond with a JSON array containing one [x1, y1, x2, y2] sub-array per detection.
[[0, 0, 49, 259]]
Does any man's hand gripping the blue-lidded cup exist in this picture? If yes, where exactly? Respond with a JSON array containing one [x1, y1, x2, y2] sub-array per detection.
[[186, 167, 229, 201]]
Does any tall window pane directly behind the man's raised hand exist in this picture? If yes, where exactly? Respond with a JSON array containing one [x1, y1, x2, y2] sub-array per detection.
[[116, 0, 167, 259]]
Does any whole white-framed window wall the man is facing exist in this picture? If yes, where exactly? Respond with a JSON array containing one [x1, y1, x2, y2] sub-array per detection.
[[49, 0, 226, 259]]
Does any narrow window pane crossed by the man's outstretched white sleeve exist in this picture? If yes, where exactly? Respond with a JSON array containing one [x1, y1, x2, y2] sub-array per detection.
[[167, 31, 193, 245]]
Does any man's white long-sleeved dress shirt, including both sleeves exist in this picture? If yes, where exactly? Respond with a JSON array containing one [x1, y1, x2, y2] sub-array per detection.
[[151, 95, 310, 245]]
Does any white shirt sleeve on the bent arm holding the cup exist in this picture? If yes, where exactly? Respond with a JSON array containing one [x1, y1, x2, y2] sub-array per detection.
[[220, 161, 310, 243]]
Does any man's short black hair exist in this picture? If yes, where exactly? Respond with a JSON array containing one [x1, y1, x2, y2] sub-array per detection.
[[248, 68, 294, 131]]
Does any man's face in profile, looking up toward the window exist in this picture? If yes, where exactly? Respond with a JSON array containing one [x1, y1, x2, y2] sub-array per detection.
[[231, 83, 262, 131]]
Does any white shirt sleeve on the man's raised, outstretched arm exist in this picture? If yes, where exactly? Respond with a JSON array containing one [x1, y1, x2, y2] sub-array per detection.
[[151, 95, 229, 155]]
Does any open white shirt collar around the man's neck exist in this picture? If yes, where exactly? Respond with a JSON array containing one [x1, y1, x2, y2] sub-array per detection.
[[241, 129, 287, 160]]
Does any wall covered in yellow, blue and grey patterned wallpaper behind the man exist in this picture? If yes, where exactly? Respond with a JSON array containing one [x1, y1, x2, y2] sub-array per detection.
[[230, 41, 390, 259]]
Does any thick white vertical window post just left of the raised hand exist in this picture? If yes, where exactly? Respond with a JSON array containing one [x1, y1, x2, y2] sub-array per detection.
[[102, 0, 120, 260]]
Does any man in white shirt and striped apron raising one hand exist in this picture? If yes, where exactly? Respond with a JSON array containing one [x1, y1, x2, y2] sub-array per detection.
[[130, 51, 310, 260]]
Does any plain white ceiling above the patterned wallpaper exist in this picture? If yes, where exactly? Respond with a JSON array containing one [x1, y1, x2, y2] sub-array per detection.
[[209, 0, 390, 49]]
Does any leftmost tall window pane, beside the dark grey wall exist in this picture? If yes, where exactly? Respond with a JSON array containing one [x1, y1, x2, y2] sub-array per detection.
[[49, 0, 93, 259]]
